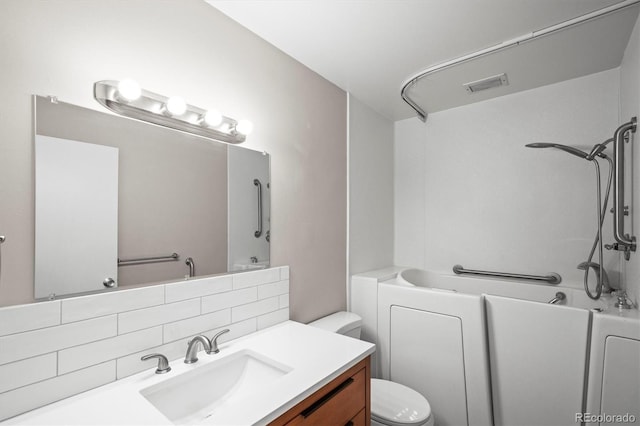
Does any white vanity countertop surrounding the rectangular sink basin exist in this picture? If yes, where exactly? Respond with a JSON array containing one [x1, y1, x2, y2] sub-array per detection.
[[3, 321, 375, 425]]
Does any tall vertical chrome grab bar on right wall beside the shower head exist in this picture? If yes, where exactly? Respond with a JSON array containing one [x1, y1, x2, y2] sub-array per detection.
[[613, 117, 637, 255]]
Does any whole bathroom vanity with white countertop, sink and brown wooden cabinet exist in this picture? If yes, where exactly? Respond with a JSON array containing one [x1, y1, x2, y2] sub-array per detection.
[[4, 321, 375, 425]]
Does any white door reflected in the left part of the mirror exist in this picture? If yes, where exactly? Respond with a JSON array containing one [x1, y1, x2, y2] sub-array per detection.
[[34, 135, 118, 298]]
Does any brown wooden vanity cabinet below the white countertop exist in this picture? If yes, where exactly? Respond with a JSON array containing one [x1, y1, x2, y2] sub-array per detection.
[[270, 357, 371, 426]]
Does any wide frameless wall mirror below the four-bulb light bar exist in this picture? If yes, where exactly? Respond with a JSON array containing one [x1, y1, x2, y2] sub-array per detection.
[[34, 96, 270, 298]]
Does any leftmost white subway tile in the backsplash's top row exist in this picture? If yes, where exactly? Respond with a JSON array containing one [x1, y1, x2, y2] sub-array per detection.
[[0, 300, 60, 336]]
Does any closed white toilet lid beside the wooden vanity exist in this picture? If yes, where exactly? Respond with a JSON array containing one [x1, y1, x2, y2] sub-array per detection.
[[371, 379, 431, 425]]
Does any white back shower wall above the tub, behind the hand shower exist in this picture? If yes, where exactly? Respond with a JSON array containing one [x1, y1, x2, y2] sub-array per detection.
[[394, 69, 629, 288]]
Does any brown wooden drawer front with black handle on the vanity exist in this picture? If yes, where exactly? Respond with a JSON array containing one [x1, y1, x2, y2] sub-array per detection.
[[289, 369, 366, 425]]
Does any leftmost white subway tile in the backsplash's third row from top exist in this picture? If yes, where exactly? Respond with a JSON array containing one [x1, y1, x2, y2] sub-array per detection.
[[0, 352, 58, 393]]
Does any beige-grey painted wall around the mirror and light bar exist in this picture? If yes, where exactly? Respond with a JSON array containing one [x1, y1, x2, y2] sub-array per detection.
[[0, 0, 347, 322]]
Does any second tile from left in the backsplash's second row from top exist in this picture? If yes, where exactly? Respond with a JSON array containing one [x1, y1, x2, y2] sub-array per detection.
[[118, 299, 200, 334]]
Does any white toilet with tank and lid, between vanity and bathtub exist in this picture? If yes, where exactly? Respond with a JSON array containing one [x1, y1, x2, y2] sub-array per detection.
[[309, 312, 434, 426]]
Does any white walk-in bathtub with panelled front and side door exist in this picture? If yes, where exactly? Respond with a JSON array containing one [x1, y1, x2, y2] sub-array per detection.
[[351, 267, 640, 426]]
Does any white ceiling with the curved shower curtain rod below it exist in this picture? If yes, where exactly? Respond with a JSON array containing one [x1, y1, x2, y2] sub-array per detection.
[[206, 0, 637, 120]]
